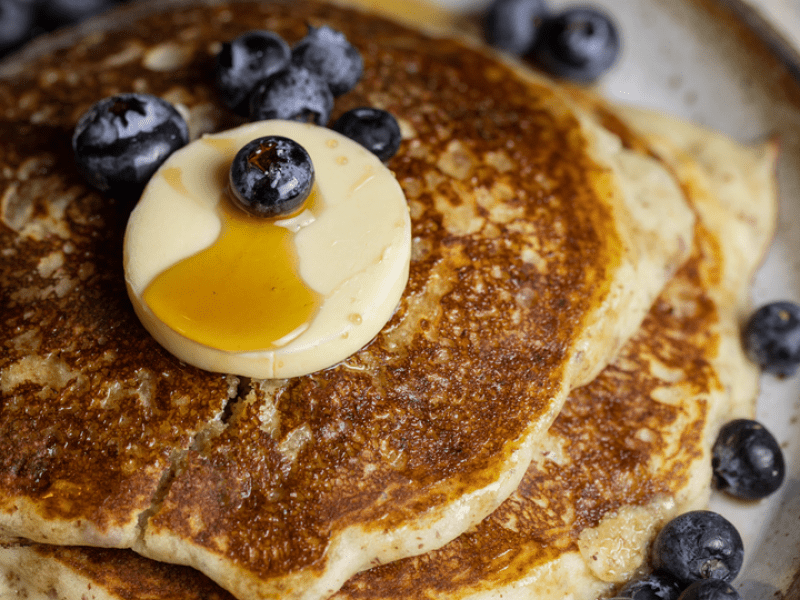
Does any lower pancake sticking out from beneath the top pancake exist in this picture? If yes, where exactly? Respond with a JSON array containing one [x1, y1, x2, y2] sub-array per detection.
[[0, 104, 776, 600]]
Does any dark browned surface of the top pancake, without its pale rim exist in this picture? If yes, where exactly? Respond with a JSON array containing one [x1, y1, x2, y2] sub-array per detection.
[[0, 2, 621, 578]]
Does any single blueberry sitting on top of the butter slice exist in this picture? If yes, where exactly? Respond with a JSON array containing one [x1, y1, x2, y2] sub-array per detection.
[[230, 135, 314, 217]]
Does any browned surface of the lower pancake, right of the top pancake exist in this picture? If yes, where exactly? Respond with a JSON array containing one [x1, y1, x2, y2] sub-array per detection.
[[336, 226, 722, 600]]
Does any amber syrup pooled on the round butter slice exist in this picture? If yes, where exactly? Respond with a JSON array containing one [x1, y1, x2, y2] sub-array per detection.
[[143, 182, 322, 352]]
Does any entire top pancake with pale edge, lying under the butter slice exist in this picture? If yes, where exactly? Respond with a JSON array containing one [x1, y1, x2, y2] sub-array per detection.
[[0, 2, 694, 600]]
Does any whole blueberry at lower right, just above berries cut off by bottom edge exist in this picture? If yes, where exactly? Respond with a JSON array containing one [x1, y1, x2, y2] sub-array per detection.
[[653, 510, 744, 585]]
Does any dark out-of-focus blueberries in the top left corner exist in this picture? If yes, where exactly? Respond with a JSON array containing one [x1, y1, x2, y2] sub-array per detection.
[[0, 0, 131, 56]]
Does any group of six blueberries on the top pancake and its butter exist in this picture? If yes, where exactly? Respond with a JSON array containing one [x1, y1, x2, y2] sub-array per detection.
[[71, 21, 401, 211]]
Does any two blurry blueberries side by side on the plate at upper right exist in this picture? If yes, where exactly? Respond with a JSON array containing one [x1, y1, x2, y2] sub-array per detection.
[[484, 0, 620, 83]]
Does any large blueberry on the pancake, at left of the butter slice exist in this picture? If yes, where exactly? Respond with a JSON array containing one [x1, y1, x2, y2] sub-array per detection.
[[72, 94, 189, 192]]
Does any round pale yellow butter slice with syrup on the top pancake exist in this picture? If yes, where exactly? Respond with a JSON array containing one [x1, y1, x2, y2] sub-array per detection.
[[123, 121, 411, 379]]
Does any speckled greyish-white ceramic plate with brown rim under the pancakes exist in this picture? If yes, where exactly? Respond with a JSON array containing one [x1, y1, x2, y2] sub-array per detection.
[[432, 0, 800, 600]]
